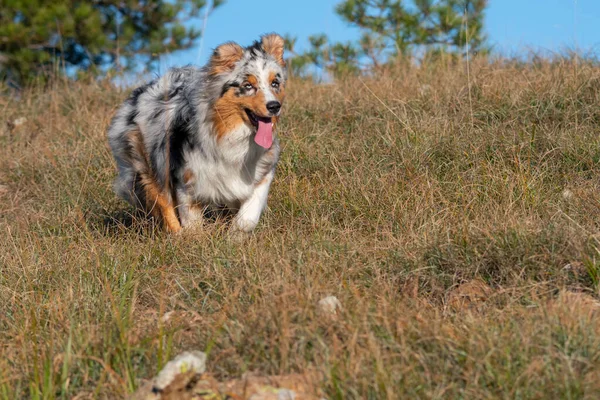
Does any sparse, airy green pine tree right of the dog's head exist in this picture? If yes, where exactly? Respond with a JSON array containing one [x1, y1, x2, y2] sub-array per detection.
[[288, 0, 488, 75]]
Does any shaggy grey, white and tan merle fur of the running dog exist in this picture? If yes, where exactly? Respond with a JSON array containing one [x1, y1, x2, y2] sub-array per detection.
[[108, 34, 287, 232]]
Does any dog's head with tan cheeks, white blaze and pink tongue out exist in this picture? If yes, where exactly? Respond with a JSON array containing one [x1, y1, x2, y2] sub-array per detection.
[[208, 34, 287, 148]]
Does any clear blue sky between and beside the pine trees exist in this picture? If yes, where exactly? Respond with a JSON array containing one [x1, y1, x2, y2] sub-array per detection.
[[160, 0, 600, 72]]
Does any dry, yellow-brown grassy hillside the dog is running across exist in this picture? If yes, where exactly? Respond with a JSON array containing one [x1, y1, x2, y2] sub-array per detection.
[[0, 57, 600, 399]]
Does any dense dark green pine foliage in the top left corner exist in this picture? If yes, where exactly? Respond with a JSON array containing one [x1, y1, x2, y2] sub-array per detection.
[[0, 0, 223, 84]]
